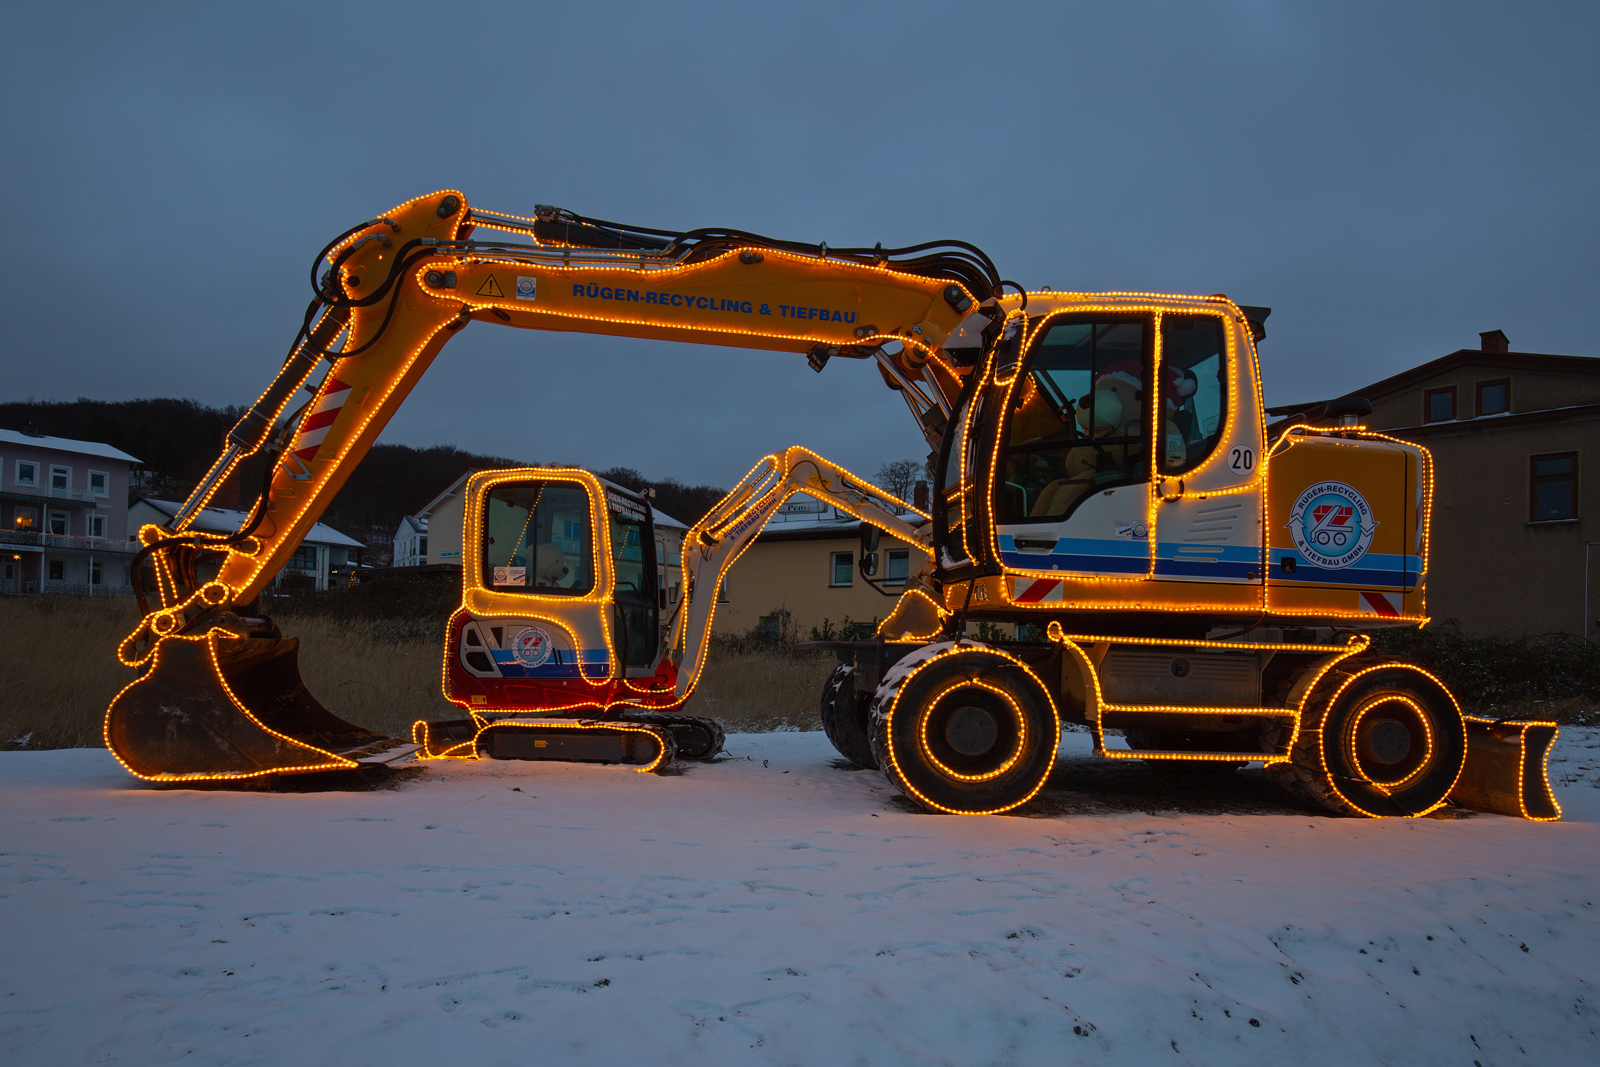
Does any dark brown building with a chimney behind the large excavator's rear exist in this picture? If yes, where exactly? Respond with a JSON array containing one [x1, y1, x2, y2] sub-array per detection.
[[1269, 330, 1600, 638]]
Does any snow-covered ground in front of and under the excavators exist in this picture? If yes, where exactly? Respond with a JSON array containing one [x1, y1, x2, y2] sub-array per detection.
[[0, 729, 1600, 1067]]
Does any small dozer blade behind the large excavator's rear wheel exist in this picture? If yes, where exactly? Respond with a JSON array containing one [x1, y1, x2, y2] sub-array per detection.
[[1450, 717, 1562, 822]]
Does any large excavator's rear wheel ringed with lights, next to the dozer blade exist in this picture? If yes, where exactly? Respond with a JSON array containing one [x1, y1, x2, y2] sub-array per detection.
[[1272, 661, 1467, 817]]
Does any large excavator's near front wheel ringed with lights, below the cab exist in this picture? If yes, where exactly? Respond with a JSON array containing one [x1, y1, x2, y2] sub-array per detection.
[[872, 641, 1061, 814]]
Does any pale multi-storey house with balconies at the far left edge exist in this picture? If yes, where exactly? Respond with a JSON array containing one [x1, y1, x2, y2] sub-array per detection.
[[0, 430, 139, 595]]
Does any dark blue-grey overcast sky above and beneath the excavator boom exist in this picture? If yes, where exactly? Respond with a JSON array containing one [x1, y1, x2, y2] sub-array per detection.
[[0, 0, 1600, 485]]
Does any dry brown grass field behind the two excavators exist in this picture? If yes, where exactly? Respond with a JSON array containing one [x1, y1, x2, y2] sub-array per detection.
[[0, 597, 834, 749]]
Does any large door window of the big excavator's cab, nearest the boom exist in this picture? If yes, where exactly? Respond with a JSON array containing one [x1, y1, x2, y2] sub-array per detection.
[[995, 320, 1150, 523]]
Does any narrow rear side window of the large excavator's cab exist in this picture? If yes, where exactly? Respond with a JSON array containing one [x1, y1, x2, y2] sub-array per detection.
[[1160, 315, 1227, 474]]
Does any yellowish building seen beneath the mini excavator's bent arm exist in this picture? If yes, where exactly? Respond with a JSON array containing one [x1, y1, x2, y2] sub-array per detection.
[[712, 494, 928, 640]]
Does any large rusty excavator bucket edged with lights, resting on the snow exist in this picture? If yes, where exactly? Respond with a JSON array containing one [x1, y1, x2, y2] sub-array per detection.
[[106, 630, 416, 781]]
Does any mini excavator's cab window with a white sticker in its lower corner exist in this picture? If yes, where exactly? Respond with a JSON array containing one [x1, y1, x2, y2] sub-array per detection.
[[483, 482, 595, 597]]
